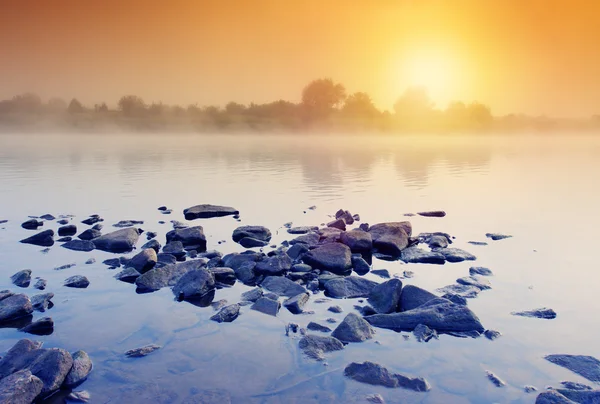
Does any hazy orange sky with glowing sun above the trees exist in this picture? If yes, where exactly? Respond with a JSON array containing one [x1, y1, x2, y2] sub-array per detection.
[[0, 0, 600, 116]]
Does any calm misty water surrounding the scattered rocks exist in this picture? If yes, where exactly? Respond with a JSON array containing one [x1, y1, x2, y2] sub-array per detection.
[[0, 135, 600, 403]]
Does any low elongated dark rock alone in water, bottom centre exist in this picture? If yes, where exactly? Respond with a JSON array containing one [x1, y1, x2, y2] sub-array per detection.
[[344, 362, 431, 391]]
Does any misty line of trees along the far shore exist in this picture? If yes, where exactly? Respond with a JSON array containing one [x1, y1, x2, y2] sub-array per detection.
[[0, 78, 600, 133]]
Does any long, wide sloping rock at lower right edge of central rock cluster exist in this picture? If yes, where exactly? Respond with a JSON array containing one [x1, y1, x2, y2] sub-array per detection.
[[365, 298, 484, 333]]
